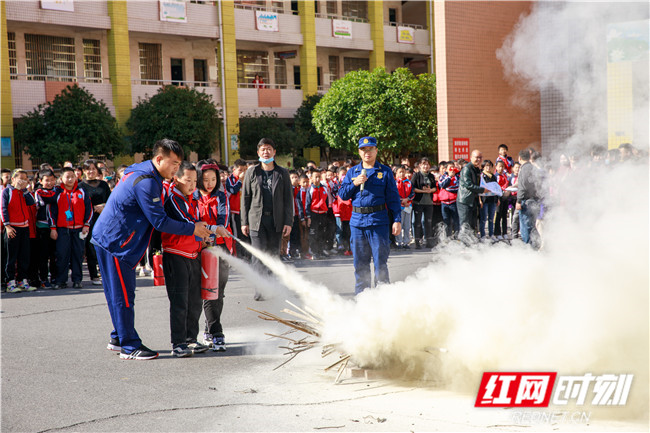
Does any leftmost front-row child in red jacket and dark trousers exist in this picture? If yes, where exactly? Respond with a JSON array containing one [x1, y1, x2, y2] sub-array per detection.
[[1, 169, 36, 293]]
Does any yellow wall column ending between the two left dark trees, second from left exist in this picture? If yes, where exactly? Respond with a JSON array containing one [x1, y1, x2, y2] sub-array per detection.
[[107, 0, 133, 128]]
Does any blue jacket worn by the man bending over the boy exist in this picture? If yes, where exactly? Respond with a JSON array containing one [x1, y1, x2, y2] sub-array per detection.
[[92, 161, 194, 268]]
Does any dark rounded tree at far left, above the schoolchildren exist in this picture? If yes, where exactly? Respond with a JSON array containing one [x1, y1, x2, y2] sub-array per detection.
[[15, 84, 125, 165]]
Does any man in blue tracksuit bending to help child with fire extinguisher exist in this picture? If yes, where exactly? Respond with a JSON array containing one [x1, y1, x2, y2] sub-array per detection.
[[91, 139, 210, 359]]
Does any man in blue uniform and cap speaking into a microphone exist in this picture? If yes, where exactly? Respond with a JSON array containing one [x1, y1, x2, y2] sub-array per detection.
[[339, 137, 402, 295]]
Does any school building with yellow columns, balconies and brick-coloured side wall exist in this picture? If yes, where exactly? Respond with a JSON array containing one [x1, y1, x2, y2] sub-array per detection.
[[0, 0, 636, 169]]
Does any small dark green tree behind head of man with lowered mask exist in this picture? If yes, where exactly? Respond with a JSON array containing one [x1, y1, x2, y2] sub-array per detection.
[[239, 113, 304, 159]]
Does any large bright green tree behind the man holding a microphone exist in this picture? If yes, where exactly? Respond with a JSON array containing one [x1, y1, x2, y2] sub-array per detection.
[[312, 68, 438, 157]]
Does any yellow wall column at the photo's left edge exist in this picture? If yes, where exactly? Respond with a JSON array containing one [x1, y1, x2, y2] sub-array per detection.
[[0, 2, 16, 168]]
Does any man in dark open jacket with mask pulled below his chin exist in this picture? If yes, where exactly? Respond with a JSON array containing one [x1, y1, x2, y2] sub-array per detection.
[[241, 138, 293, 301]]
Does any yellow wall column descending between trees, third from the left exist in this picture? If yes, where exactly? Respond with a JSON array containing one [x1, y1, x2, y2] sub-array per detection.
[[219, 0, 239, 164]]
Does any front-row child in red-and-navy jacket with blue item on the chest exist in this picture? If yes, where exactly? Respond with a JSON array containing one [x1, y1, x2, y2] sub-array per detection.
[[49, 167, 93, 289]]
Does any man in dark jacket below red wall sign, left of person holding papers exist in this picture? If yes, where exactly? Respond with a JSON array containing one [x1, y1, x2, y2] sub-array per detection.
[[456, 150, 488, 243]]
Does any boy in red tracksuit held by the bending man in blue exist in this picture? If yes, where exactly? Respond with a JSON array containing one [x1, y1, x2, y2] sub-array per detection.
[[161, 161, 215, 358]]
